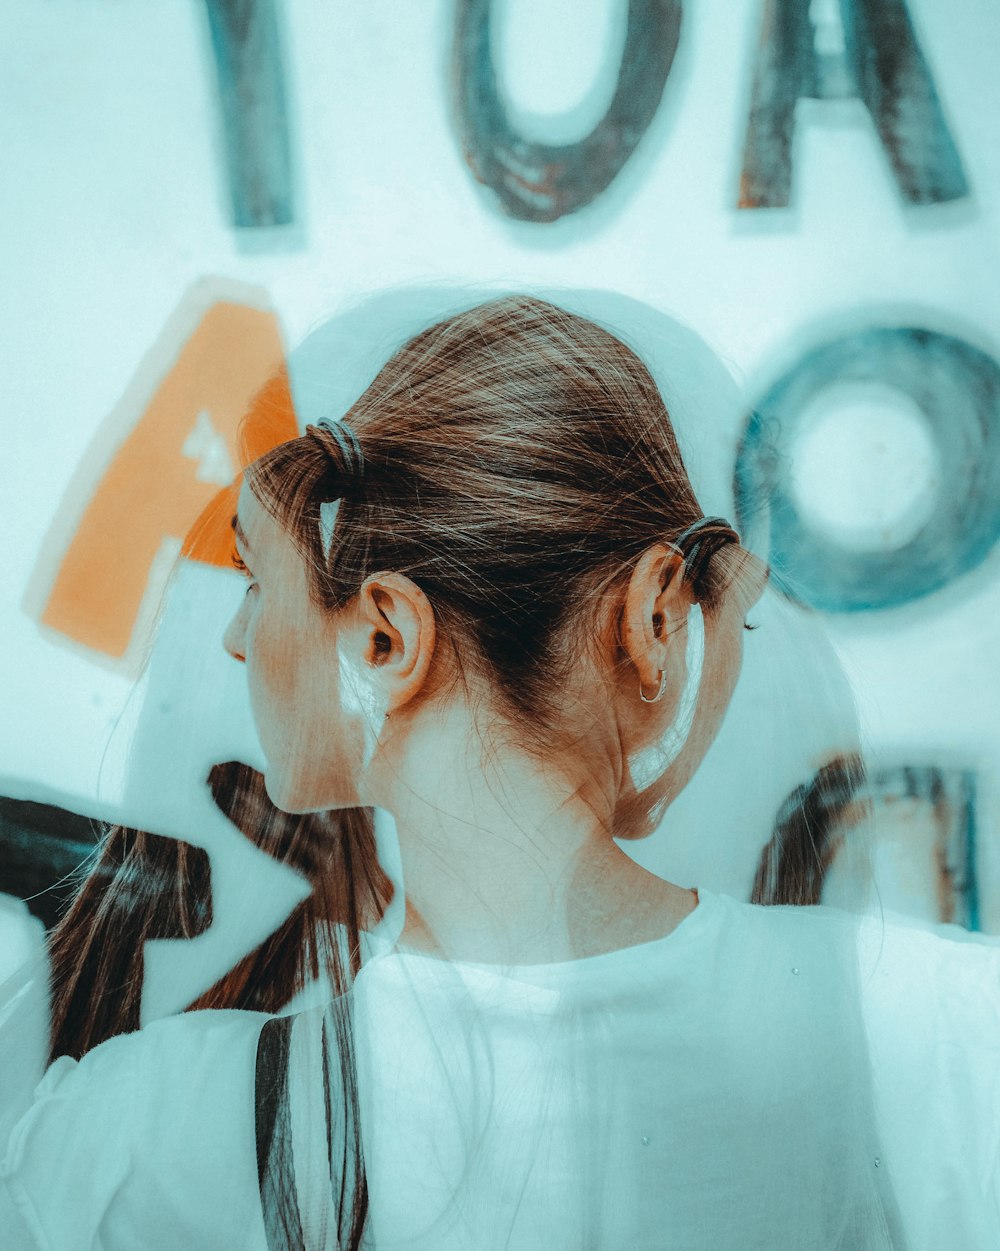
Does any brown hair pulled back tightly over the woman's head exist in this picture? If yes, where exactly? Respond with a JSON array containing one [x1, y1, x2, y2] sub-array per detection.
[[247, 295, 732, 746]]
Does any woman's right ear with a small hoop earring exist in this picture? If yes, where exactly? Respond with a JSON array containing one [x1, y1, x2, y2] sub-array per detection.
[[621, 543, 691, 692]]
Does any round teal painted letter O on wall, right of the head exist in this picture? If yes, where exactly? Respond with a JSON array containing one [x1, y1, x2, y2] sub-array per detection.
[[735, 327, 1000, 613]]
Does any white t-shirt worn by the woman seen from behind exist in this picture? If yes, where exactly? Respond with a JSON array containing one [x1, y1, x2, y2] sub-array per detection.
[[0, 891, 1000, 1251]]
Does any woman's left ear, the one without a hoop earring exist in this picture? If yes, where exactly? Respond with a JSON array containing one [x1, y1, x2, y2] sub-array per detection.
[[358, 573, 437, 712]]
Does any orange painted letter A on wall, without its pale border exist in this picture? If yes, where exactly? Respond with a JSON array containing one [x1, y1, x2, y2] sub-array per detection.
[[41, 301, 298, 657]]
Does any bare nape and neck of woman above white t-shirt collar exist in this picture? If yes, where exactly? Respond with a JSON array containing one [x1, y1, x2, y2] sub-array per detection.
[[362, 703, 693, 965]]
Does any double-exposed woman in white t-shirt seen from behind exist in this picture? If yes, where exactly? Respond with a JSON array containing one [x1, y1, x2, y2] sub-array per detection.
[[3, 298, 1000, 1251]]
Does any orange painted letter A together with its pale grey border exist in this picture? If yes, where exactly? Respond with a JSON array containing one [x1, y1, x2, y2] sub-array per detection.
[[25, 290, 298, 668]]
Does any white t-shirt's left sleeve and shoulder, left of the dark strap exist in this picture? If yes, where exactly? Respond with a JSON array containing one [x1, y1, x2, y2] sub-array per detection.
[[0, 1011, 274, 1251]]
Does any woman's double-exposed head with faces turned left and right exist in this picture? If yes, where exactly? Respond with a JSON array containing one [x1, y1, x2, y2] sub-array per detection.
[[227, 296, 762, 825]]
